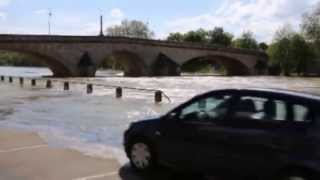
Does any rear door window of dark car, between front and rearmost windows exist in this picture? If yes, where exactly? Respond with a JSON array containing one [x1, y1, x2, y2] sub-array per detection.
[[234, 96, 288, 121]]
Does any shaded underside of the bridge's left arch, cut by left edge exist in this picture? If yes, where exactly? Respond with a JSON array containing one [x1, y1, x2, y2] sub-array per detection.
[[0, 47, 72, 77]]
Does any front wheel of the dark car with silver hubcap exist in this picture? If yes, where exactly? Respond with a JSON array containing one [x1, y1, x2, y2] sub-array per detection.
[[128, 138, 157, 174]]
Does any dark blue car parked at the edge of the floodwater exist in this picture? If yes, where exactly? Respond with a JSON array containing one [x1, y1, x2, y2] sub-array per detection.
[[124, 89, 320, 180]]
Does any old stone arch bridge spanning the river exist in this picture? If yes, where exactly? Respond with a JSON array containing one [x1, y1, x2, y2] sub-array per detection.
[[0, 35, 268, 77]]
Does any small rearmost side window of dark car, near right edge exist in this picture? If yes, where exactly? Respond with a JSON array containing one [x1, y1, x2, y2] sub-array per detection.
[[292, 104, 312, 122]]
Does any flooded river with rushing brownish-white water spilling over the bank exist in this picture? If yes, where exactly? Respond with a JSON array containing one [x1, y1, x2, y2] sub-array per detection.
[[0, 67, 320, 163]]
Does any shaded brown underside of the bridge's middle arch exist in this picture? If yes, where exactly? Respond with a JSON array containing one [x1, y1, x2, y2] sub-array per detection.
[[98, 50, 148, 77]]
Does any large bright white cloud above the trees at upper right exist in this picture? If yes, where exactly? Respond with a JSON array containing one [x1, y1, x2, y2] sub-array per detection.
[[162, 0, 319, 41]]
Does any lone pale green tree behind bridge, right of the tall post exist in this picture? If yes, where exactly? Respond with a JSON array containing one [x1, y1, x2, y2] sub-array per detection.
[[106, 19, 154, 39]]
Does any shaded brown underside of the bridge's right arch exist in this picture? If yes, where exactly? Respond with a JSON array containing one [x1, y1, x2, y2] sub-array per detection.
[[181, 55, 252, 76]]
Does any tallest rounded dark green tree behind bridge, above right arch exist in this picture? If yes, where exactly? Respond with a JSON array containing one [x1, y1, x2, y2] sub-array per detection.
[[209, 27, 233, 47]]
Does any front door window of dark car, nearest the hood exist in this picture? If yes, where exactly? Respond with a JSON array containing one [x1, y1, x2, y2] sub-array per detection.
[[180, 96, 231, 122]]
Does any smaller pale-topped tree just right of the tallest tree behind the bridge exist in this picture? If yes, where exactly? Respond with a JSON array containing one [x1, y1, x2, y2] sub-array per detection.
[[233, 31, 258, 50]]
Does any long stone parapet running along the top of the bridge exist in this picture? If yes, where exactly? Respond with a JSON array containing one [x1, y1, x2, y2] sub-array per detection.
[[0, 34, 266, 56]]
